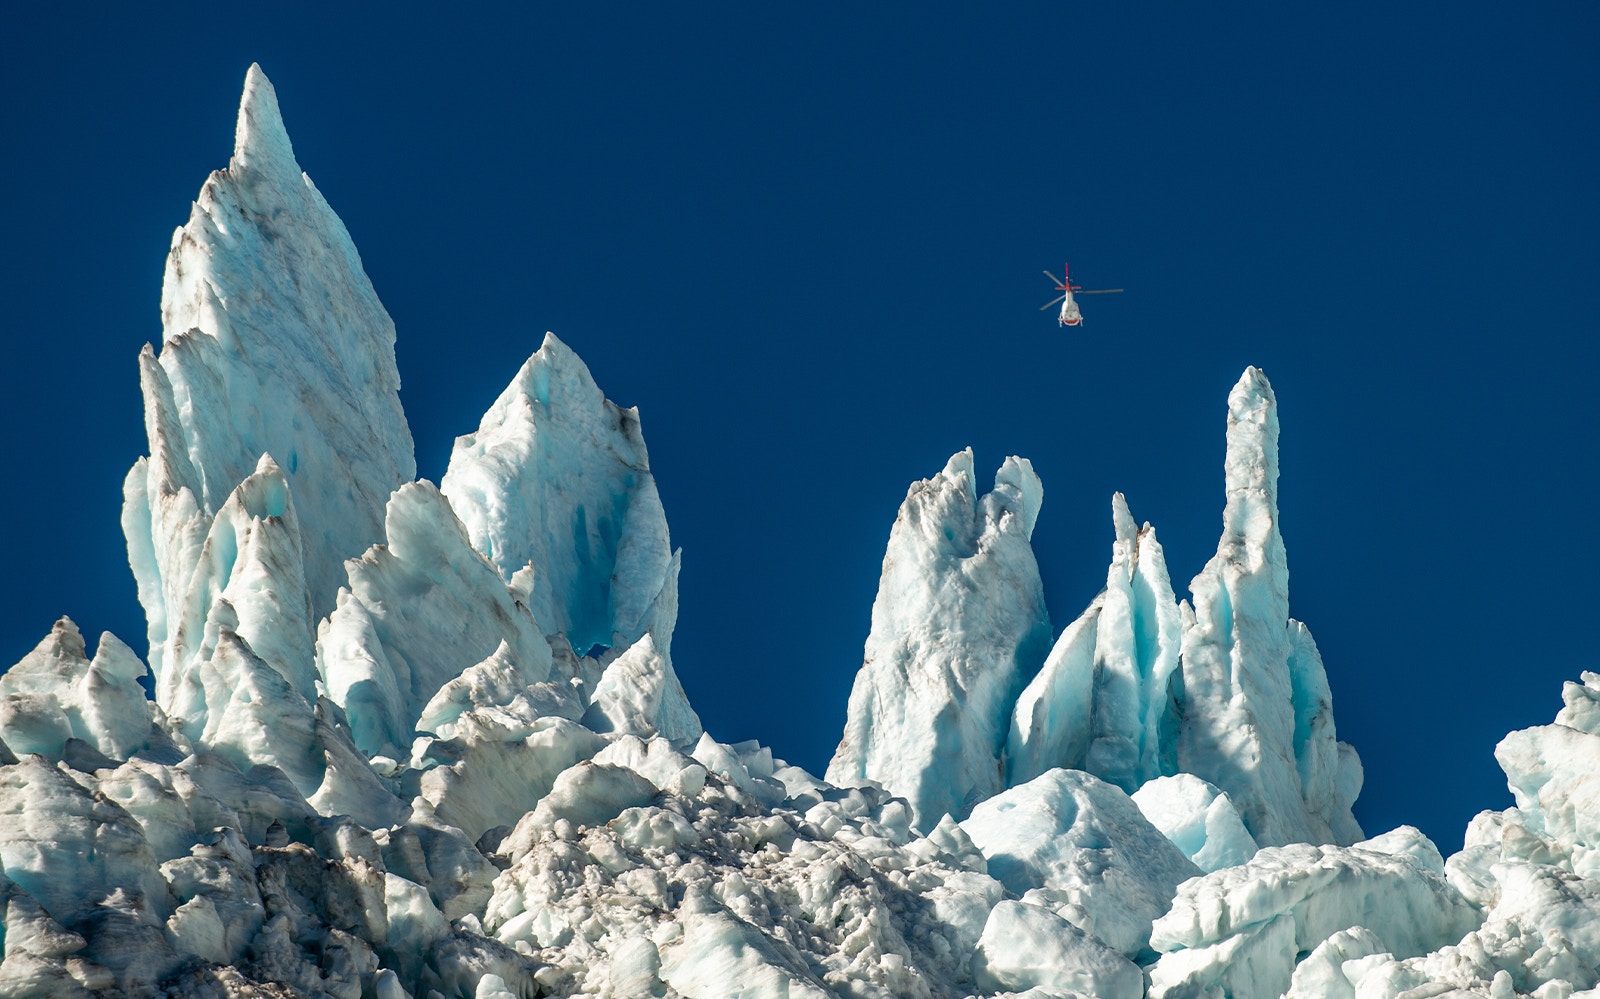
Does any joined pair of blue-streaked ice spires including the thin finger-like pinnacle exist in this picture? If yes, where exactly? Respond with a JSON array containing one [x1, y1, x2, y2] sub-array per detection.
[[1006, 368, 1362, 850]]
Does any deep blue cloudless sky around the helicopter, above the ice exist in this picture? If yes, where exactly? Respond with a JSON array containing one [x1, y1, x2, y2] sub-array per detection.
[[0, 3, 1600, 850]]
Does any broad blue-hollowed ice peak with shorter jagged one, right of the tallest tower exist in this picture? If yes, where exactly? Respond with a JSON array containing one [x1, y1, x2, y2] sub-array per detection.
[[317, 304, 701, 759]]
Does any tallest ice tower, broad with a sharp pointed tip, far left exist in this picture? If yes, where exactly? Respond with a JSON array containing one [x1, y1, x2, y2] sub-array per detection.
[[122, 66, 416, 711]]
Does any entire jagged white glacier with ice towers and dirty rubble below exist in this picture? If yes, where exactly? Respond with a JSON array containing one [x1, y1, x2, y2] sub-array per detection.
[[0, 66, 1600, 999]]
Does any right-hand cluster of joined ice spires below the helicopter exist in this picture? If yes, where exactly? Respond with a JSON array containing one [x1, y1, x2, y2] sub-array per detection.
[[829, 368, 1362, 857]]
